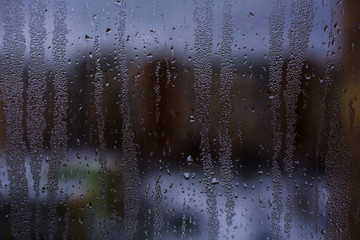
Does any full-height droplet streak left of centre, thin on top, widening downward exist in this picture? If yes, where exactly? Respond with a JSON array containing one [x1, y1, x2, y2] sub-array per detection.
[[118, 0, 140, 239]]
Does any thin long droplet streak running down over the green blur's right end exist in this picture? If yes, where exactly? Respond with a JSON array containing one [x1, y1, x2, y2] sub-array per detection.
[[93, 24, 107, 238]]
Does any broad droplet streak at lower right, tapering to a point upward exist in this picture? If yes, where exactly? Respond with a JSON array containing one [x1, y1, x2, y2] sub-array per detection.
[[325, 100, 351, 239]]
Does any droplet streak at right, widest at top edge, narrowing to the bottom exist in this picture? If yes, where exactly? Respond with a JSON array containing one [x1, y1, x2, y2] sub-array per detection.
[[284, 0, 314, 239]]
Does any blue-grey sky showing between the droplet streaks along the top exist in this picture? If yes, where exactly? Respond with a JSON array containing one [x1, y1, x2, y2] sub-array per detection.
[[0, 0, 341, 60]]
